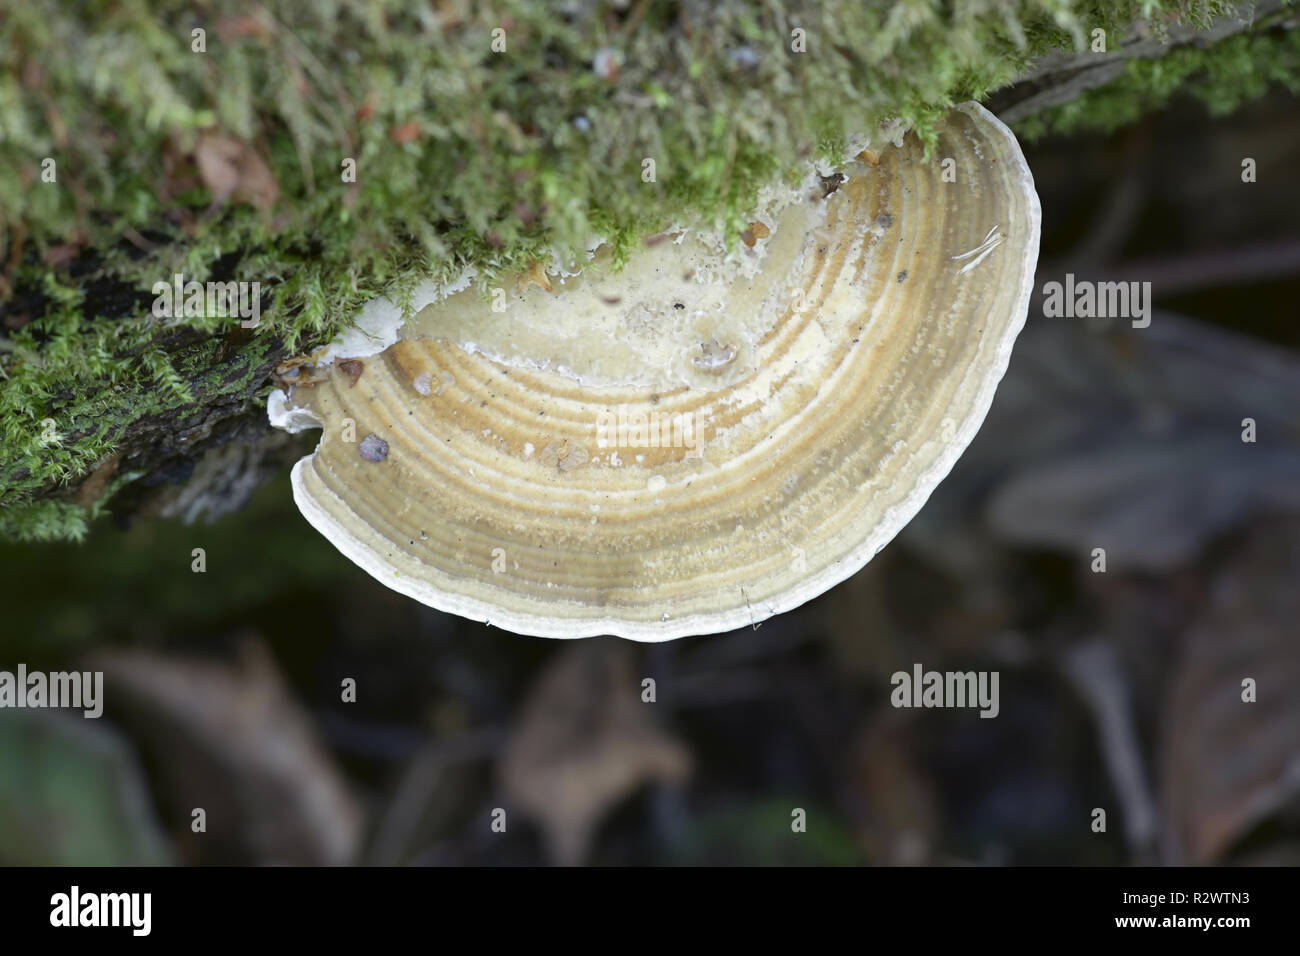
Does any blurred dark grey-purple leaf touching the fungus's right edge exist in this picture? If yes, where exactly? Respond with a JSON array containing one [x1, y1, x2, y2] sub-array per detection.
[[901, 311, 1300, 576]]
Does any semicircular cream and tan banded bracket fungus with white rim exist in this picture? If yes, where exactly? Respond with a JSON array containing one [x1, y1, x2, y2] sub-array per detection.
[[270, 103, 1040, 641]]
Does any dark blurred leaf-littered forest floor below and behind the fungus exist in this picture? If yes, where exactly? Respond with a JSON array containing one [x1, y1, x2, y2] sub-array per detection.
[[0, 89, 1300, 865]]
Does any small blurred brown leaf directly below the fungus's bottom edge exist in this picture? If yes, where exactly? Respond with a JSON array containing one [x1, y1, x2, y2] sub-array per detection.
[[501, 640, 692, 866]]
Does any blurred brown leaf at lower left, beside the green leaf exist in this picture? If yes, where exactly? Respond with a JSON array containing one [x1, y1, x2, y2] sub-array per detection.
[[87, 640, 363, 866]]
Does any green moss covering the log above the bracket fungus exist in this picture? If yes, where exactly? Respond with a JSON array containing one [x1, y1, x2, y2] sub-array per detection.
[[0, 0, 1294, 537]]
